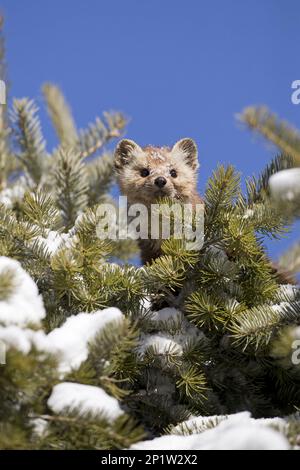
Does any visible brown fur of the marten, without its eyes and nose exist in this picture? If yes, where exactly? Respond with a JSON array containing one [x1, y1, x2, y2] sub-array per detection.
[[115, 139, 297, 284]]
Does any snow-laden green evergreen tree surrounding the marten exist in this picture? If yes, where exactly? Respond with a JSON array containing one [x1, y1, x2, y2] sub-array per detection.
[[0, 20, 300, 449]]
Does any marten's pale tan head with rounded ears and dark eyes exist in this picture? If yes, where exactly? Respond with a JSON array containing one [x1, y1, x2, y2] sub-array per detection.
[[115, 139, 199, 204]]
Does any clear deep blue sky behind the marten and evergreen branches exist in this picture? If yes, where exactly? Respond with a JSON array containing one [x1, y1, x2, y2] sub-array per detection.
[[0, 0, 300, 257]]
